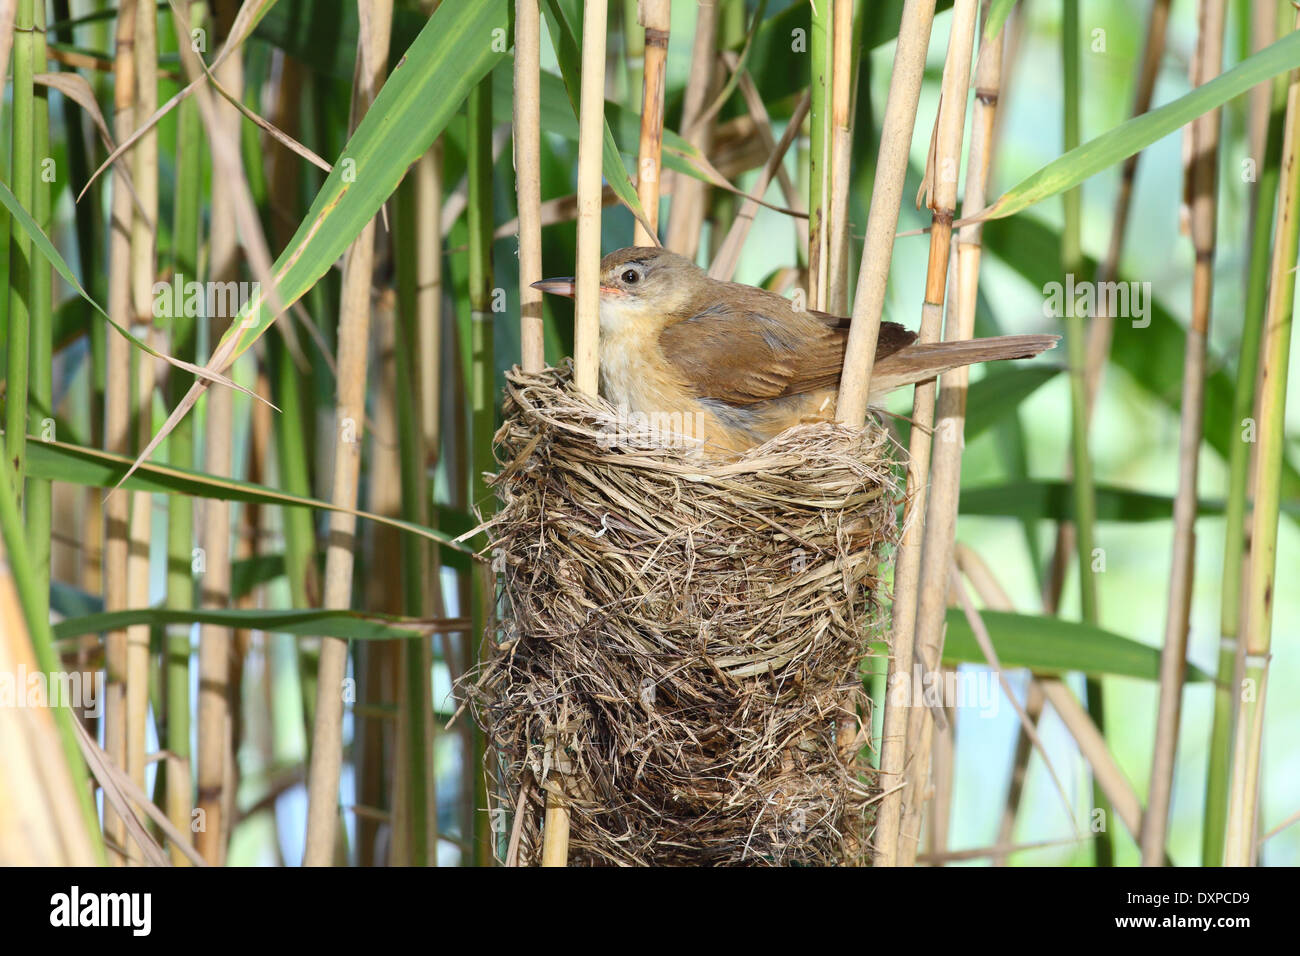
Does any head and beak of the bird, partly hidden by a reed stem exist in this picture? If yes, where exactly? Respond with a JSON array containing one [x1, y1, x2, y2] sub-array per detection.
[[533, 246, 710, 332]]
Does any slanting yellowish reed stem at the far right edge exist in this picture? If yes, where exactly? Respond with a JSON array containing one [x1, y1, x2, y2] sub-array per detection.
[[1223, 7, 1300, 866]]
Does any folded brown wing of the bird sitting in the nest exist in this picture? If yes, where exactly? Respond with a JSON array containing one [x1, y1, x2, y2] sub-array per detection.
[[659, 300, 845, 406]]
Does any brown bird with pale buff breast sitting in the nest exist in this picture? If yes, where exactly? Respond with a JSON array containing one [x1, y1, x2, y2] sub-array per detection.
[[533, 247, 1060, 451]]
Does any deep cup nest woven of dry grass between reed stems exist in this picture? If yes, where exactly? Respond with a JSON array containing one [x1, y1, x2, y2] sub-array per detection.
[[467, 368, 898, 865]]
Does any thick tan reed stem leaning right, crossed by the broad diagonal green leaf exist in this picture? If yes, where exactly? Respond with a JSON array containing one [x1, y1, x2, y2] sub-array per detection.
[[303, 0, 393, 866]]
